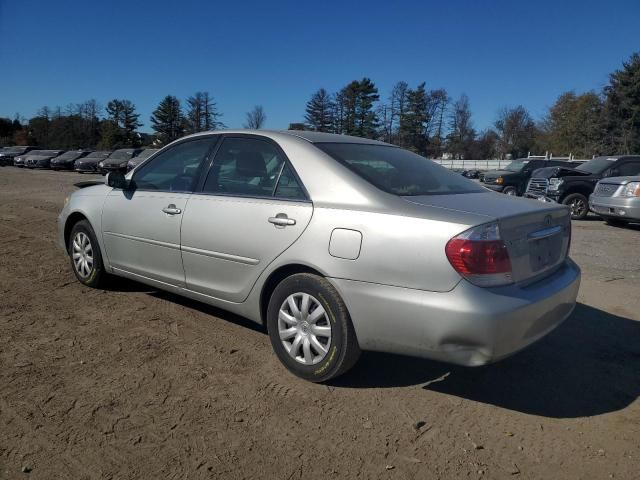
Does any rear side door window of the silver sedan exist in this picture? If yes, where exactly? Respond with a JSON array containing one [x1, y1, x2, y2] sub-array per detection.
[[203, 138, 305, 199]]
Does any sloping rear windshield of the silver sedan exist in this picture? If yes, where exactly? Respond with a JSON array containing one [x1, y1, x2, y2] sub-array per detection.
[[314, 143, 485, 196]]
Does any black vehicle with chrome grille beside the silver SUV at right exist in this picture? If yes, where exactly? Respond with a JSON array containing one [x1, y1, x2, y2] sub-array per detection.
[[526, 155, 640, 220]]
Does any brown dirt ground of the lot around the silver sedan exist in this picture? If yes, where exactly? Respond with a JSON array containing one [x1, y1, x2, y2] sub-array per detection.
[[0, 167, 640, 480]]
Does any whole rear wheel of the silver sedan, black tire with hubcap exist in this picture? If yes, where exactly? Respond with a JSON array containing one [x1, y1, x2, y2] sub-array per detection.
[[267, 273, 360, 382]]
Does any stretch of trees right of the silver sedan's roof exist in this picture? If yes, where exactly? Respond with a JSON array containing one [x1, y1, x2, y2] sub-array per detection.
[[300, 53, 640, 159]]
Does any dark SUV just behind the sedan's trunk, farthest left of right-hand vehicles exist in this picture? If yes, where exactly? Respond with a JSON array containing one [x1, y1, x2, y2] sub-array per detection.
[[480, 158, 580, 197]]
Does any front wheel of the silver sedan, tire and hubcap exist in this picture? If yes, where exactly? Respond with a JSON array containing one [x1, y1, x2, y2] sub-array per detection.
[[67, 220, 108, 288]]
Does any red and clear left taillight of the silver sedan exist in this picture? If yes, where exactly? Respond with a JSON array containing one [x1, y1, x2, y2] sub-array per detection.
[[445, 222, 513, 287]]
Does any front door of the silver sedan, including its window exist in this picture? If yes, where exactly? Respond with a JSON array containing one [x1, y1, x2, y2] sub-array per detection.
[[102, 136, 218, 286]]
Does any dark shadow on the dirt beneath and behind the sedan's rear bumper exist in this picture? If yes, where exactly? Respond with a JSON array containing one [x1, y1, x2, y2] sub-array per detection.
[[332, 304, 640, 418]]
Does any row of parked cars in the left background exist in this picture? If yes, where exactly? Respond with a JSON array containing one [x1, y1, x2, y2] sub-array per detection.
[[0, 146, 158, 174]]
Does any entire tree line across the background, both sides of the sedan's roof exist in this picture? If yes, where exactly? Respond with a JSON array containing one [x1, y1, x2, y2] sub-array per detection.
[[0, 53, 640, 159]]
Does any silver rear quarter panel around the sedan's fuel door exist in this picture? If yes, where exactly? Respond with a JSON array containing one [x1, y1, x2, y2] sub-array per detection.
[[269, 207, 468, 292]]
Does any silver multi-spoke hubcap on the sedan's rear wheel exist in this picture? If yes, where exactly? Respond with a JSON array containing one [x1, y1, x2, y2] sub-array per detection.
[[278, 292, 331, 365]]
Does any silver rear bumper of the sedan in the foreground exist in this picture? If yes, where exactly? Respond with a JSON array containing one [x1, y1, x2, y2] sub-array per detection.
[[331, 259, 580, 366]]
